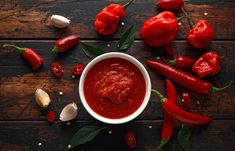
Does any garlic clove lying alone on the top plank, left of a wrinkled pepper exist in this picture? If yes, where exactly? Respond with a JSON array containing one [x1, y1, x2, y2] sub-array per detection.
[[51, 15, 70, 28]]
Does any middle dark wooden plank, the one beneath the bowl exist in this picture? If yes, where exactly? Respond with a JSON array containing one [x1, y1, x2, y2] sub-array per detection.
[[0, 41, 235, 120]]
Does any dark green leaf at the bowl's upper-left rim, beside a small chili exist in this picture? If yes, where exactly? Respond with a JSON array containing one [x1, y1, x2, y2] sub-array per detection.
[[80, 42, 105, 58]]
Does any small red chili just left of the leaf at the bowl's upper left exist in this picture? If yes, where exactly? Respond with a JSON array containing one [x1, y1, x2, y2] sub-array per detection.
[[52, 35, 80, 52]]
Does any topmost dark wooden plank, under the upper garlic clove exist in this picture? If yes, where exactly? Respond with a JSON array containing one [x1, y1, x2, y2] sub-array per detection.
[[0, 0, 235, 39]]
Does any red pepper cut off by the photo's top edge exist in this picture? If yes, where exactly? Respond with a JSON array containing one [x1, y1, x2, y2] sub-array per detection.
[[156, 0, 184, 10]]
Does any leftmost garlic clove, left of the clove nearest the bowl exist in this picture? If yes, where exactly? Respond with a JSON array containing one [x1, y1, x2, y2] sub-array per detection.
[[35, 89, 51, 108]]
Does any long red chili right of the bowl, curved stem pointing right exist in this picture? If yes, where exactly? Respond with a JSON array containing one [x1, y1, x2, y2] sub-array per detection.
[[147, 60, 232, 95]]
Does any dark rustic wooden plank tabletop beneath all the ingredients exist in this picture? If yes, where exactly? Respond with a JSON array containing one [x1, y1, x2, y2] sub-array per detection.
[[0, 0, 235, 151]]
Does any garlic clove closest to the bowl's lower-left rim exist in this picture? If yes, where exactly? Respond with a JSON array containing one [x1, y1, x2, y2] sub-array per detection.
[[60, 102, 78, 121]]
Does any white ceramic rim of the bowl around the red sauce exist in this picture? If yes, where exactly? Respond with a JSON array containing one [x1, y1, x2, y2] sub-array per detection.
[[79, 52, 151, 124]]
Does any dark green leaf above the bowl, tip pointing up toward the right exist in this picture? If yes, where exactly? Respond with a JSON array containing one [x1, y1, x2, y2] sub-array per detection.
[[117, 25, 136, 51]]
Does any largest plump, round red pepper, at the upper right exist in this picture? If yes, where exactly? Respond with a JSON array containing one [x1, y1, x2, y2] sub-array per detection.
[[140, 11, 179, 47]]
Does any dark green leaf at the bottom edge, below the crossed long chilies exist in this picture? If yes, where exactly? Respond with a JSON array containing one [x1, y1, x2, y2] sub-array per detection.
[[177, 125, 191, 151]]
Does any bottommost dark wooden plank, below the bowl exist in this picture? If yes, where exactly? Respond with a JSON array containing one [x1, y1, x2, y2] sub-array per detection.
[[0, 120, 235, 151]]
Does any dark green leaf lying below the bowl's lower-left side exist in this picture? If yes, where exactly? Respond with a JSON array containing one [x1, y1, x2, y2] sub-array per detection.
[[65, 125, 106, 150]]
